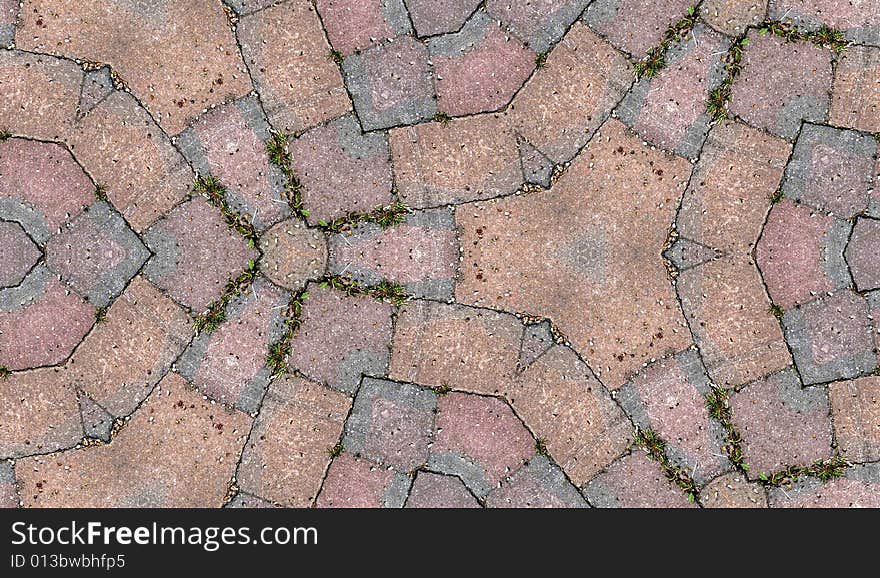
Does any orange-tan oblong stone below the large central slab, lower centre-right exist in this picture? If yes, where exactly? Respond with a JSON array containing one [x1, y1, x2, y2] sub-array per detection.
[[507, 345, 632, 486]]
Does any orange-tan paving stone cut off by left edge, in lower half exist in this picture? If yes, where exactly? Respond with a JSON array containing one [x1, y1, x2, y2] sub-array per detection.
[[0, 368, 83, 459]]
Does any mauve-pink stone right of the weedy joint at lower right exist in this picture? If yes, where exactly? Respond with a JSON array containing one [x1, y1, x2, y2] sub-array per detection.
[[730, 369, 831, 479]]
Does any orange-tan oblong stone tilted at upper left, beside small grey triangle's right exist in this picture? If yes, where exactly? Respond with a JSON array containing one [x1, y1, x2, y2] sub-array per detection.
[[70, 92, 193, 233]]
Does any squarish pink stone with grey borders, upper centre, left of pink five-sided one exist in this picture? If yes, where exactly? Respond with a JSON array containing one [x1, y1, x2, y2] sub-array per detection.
[[343, 36, 437, 130]]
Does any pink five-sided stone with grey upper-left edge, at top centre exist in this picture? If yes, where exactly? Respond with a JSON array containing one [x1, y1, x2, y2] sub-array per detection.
[[428, 12, 535, 116]]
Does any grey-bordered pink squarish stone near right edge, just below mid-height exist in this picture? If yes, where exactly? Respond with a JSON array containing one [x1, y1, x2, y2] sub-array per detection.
[[782, 290, 877, 384]]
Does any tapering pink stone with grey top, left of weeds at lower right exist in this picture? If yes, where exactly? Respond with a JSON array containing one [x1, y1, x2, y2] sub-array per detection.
[[617, 350, 728, 484]]
